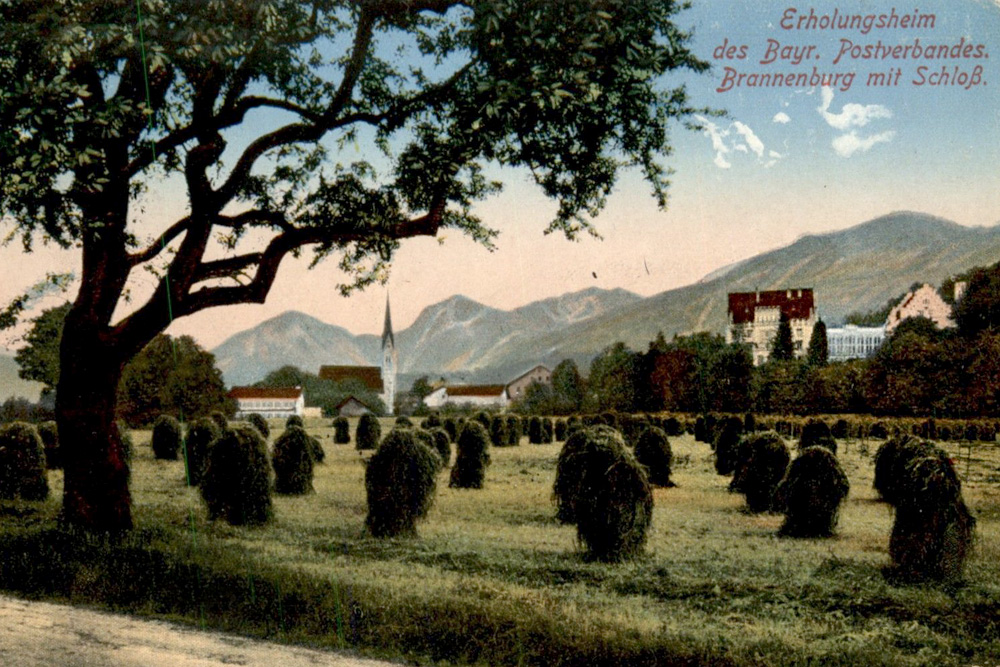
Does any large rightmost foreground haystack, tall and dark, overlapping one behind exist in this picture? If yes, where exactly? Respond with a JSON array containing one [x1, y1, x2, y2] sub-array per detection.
[[889, 450, 976, 582]]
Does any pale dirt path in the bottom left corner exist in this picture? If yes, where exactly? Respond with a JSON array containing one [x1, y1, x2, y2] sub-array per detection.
[[0, 596, 392, 667]]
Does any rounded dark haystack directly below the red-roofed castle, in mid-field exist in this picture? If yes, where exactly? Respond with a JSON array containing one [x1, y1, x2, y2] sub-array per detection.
[[729, 431, 791, 512]]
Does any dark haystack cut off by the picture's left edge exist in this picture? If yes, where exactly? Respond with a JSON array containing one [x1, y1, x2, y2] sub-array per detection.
[[0, 422, 49, 500]]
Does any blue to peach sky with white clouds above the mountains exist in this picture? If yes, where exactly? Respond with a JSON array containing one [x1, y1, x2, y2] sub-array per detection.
[[0, 0, 1000, 348]]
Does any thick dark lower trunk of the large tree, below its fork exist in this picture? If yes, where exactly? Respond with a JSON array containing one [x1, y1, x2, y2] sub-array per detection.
[[56, 313, 132, 534]]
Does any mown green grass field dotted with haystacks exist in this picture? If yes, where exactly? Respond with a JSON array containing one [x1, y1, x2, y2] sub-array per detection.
[[0, 421, 1000, 665]]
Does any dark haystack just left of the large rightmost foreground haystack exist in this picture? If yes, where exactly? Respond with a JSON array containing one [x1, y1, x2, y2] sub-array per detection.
[[774, 447, 850, 537]]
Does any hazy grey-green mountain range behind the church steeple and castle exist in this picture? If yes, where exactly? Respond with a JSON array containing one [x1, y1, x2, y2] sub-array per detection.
[[213, 212, 1000, 387]]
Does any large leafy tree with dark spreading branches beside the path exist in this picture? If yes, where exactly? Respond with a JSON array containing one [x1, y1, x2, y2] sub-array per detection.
[[0, 0, 706, 532]]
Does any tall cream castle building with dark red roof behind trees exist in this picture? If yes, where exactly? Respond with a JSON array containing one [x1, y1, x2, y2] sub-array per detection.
[[726, 288, 817, 366]]
